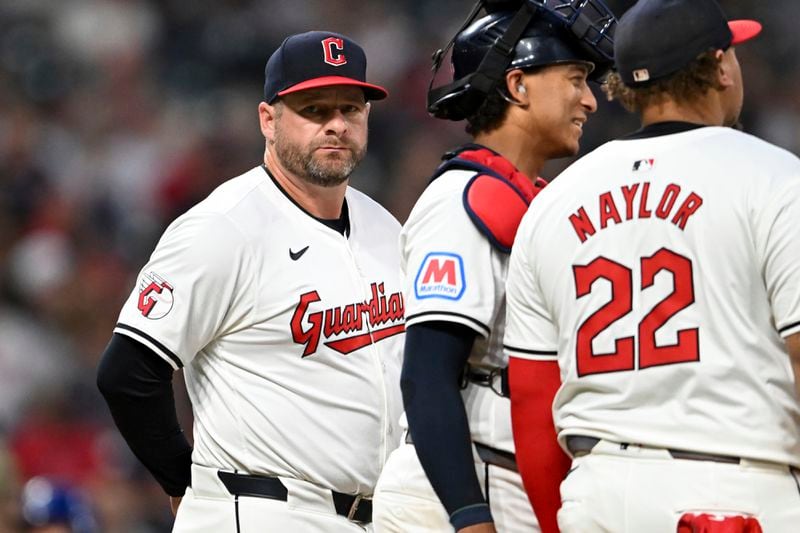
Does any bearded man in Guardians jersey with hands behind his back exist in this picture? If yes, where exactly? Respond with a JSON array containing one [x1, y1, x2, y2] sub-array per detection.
[[98, 31, 404, 533]]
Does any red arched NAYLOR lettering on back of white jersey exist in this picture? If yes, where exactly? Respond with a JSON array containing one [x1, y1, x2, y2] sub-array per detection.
[[569, 181, 703, 243]]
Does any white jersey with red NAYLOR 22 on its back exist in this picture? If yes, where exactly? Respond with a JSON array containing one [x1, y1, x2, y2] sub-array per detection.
[[505, 127, 800, 465]]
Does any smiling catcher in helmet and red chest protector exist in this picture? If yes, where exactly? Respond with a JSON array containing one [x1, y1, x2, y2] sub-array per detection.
[[375, 1, 615, 533]]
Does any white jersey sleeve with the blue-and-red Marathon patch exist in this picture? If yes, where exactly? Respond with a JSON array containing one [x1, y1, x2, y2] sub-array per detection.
[[400, 170, 505, 337]]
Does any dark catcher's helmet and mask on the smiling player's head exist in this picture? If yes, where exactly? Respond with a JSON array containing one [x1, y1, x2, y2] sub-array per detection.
[[428, 0, 617, 120]]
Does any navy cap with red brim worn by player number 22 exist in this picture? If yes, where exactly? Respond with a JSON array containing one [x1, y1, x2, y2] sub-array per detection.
[[614, 0, 761, 85]]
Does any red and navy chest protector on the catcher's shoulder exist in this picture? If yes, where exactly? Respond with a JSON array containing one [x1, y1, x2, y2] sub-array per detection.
[[431, 144, 547, 253]]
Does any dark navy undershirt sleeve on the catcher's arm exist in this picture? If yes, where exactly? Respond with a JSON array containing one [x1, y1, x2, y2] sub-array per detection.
[[400, 321, 492, 530]]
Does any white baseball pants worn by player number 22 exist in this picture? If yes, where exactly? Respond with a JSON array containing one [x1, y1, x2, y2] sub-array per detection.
[[558, 440, 800, 533]]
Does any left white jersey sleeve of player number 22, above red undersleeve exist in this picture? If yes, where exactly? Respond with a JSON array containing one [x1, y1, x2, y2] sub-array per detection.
[[503, 216, 558, 361]]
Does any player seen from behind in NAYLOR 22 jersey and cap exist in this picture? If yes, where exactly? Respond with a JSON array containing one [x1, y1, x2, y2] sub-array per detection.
[[505, 0, 800, 533]]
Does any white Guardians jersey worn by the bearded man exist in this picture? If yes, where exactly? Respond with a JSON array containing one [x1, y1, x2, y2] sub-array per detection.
[[114, 167, 404, 494]]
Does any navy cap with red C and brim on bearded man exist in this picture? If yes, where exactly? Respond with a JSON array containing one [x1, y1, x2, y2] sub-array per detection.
[[264, 31, 389, 104]]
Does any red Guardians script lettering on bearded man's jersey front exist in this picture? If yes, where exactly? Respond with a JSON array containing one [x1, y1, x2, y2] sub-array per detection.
[[291, 283, 405, 357]]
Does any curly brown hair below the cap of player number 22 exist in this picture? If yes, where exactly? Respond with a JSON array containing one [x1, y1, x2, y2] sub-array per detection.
[[603, 50, 720, 113]]
